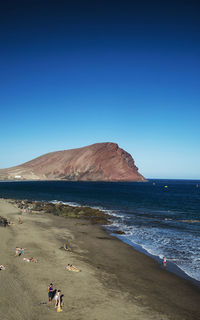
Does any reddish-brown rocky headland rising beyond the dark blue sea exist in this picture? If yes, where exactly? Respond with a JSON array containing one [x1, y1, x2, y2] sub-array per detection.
[[0, 142, 145, 181]]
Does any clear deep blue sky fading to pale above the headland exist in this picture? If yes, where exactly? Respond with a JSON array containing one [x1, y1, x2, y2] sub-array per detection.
[[0, 0, 200, 179]]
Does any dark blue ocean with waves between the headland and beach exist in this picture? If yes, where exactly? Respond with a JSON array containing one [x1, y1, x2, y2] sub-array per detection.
[[0, 180, 200, 281]]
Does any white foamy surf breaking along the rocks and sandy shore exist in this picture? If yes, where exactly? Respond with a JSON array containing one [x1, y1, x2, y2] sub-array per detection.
[[48, 200, 200, 281]]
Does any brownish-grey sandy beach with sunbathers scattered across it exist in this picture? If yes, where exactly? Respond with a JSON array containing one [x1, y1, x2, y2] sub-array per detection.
[[0, 199, 200, 320]]
